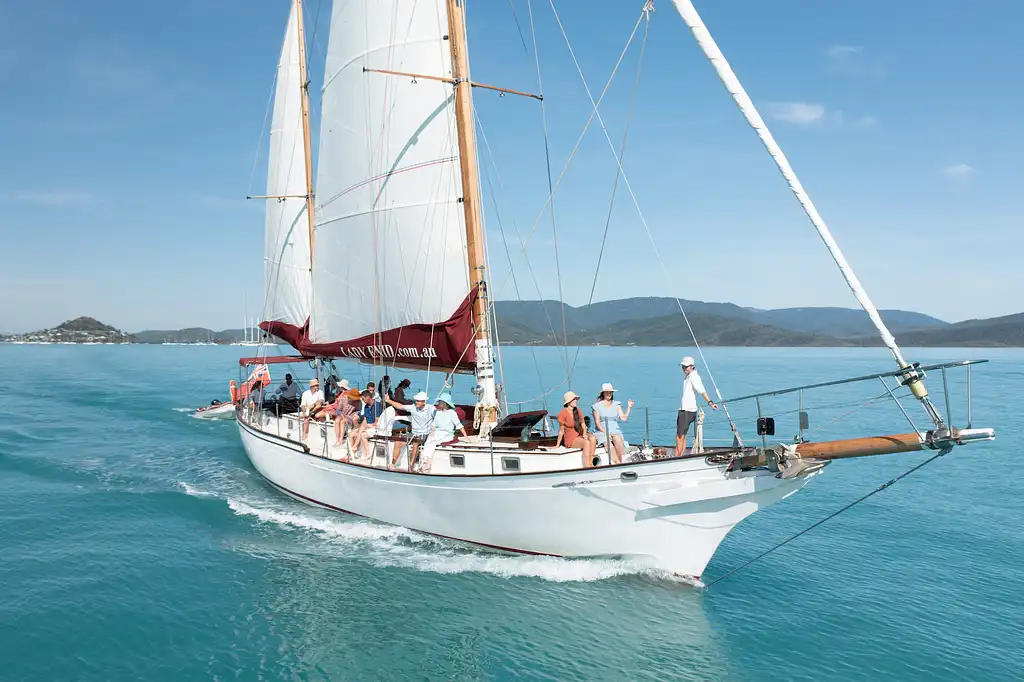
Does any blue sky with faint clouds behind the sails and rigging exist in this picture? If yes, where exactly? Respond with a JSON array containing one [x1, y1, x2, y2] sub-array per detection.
[[0, 0, 1024, 332]]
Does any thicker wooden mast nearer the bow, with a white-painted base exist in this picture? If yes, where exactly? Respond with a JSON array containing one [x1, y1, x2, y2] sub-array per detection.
[[447, 0, 498, 425]]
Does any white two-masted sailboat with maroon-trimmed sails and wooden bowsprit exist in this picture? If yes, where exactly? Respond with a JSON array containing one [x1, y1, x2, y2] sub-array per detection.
[[236, 0, 994, 584]]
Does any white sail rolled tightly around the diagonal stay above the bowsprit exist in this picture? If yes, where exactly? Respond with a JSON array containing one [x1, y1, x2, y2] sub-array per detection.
[[673, 0, 907, 368]]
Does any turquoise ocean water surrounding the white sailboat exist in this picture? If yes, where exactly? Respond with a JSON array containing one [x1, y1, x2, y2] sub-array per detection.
[[0, 345, 1024, 681]]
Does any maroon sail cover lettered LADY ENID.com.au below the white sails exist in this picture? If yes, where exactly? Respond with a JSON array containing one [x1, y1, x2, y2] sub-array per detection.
[[259, 288, 478, 371]]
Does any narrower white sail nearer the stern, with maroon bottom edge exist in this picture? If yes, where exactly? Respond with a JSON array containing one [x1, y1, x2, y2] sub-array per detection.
[[260, 3, 311, 347]]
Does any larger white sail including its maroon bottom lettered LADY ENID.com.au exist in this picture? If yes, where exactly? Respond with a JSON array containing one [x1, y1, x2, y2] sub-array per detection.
[[303, 0, 476, 369]]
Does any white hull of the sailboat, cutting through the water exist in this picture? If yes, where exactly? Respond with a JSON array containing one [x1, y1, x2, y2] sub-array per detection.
[[239, 411, 809, 582]]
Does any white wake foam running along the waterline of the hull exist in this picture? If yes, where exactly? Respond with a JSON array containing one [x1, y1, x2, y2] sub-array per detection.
[[227, 498, 679, 583]]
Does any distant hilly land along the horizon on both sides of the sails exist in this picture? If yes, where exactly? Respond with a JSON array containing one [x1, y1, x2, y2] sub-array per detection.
[[0, 297, 1024, 347]]
